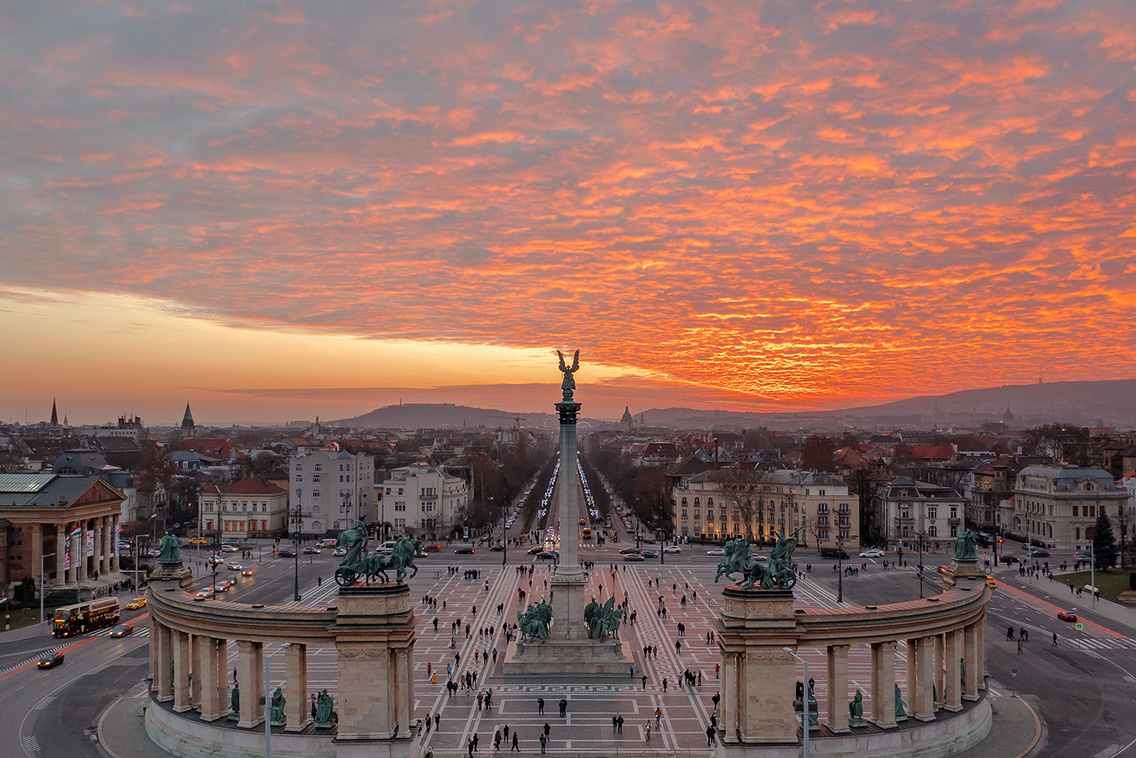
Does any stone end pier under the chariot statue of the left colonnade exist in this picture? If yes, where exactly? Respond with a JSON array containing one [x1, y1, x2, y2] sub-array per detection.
[[333, 582, 415, 756]]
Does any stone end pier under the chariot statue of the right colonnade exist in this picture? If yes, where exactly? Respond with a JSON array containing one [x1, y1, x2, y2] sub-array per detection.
[[718, 585, 797, 748]]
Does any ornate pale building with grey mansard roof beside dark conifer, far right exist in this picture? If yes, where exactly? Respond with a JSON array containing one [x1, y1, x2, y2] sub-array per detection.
[[1010, 466, 1128, 550]]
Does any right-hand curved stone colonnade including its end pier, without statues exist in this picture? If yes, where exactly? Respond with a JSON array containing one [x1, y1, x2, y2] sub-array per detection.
[[719, 586, 988, 745]]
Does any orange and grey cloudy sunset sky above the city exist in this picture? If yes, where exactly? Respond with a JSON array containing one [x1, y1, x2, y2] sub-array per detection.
[[0, 0, 1136, 424]]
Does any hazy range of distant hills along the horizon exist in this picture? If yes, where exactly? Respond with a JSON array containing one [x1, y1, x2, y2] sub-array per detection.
[[332, 380, 1136, 430]]
